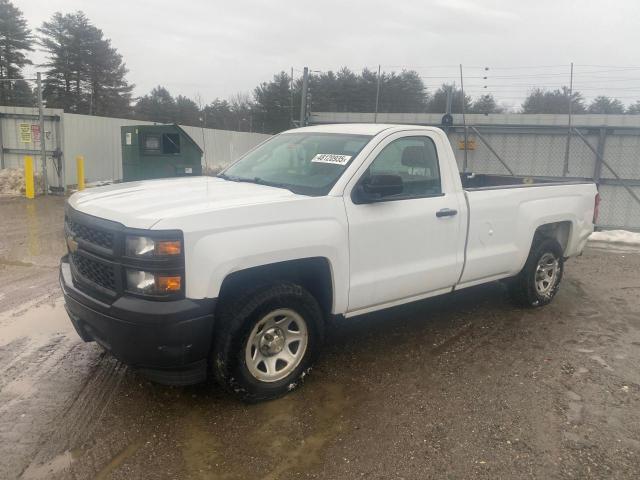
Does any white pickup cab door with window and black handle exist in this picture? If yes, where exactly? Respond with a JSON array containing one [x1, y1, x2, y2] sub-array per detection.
[[345, 131, 464, 313]]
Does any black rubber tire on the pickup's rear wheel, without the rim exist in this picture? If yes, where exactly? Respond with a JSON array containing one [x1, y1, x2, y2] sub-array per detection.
[[507, 237, 564, 308]]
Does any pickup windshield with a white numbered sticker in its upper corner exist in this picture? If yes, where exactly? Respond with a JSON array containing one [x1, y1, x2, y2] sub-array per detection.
[[219, 132, 371, 195]]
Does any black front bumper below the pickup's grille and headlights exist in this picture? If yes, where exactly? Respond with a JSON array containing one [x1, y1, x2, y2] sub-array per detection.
[[60, 256, 216, 385]]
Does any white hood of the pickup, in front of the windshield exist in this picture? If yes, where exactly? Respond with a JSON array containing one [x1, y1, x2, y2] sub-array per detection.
[[69, 177, 307, 228]]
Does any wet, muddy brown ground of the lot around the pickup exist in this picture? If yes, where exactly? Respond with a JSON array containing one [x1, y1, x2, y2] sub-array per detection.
[[0, 198, 640, 479]]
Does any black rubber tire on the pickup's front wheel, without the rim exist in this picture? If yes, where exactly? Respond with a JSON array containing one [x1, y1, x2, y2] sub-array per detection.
[[212, 283, 324, 403]]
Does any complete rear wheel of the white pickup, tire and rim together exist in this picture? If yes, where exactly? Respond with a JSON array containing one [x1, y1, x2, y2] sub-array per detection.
[[508, 237, 564, 307]]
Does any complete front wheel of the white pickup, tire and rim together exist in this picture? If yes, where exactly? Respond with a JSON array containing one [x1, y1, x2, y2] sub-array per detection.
[[213, 283, 323, 402]]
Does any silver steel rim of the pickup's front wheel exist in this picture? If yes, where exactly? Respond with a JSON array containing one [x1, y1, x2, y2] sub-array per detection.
[[245, 308, 309, 382]]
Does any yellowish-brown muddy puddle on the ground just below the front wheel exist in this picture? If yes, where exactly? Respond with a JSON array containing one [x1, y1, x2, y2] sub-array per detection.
[[180, 382, 353, 480]]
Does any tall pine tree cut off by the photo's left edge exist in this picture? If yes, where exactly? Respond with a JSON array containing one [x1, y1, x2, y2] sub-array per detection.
[[0, 0, 33, 106]]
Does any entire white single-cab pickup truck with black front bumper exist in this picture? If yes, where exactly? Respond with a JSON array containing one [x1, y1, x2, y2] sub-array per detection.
[[60, 124, 598, 401]]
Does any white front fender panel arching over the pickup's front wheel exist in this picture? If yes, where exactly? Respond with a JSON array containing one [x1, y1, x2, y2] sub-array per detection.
[[162, 196, 349, 313]]
